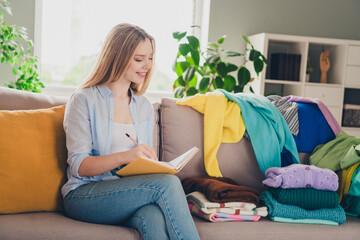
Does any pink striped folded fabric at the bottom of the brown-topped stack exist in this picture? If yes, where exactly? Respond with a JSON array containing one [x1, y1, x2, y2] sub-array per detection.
[[188, 202, 261, 222]]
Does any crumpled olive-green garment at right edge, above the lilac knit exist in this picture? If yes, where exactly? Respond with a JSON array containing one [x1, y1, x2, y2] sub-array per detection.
[[309, 131, 360, 171]]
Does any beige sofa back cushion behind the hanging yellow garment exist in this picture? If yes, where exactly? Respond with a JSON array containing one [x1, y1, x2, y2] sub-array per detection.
[[160, 98, 265, 191]]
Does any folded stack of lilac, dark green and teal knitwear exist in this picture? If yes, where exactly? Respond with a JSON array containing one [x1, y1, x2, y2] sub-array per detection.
[[260, 164, 346, 225]]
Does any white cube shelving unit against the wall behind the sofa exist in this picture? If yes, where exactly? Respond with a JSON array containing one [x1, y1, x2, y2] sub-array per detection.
[[248, 33, 360, 137]]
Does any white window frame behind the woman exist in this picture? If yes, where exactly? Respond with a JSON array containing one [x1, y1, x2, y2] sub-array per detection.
[[34, 0, 210, 101]]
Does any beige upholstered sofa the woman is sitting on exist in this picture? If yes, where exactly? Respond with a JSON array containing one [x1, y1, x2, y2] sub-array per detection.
[[0, 87, 360, 240]]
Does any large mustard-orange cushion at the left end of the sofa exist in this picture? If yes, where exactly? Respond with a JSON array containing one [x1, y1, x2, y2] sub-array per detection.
[[0, 105, 67, 213]]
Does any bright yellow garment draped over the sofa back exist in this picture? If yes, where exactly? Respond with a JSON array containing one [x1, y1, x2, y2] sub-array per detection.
[[176, 92, 245, 177]]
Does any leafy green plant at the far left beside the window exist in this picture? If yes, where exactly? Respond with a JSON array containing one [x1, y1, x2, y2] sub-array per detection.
[[0, 0, 44, 92]]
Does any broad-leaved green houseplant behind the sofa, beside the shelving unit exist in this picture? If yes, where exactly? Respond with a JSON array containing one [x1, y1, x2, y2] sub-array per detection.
[[173, 27, 266, 98]]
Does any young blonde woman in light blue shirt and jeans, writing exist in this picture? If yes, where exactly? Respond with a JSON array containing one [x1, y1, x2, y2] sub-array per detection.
[[62, 24, 199, 240]]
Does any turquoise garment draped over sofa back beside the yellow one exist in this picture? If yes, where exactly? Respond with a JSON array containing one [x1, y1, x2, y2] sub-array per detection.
[[216, 89, 300, 174]]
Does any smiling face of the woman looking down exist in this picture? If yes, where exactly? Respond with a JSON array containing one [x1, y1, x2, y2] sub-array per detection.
[[124, 39, 153, 84]]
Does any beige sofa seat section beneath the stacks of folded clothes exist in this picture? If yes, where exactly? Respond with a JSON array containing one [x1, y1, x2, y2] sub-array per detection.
[[194, 216, 360, 240]]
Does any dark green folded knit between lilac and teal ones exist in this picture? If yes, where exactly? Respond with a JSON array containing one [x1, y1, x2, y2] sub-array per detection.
[[269, 187, 339, 209]]
